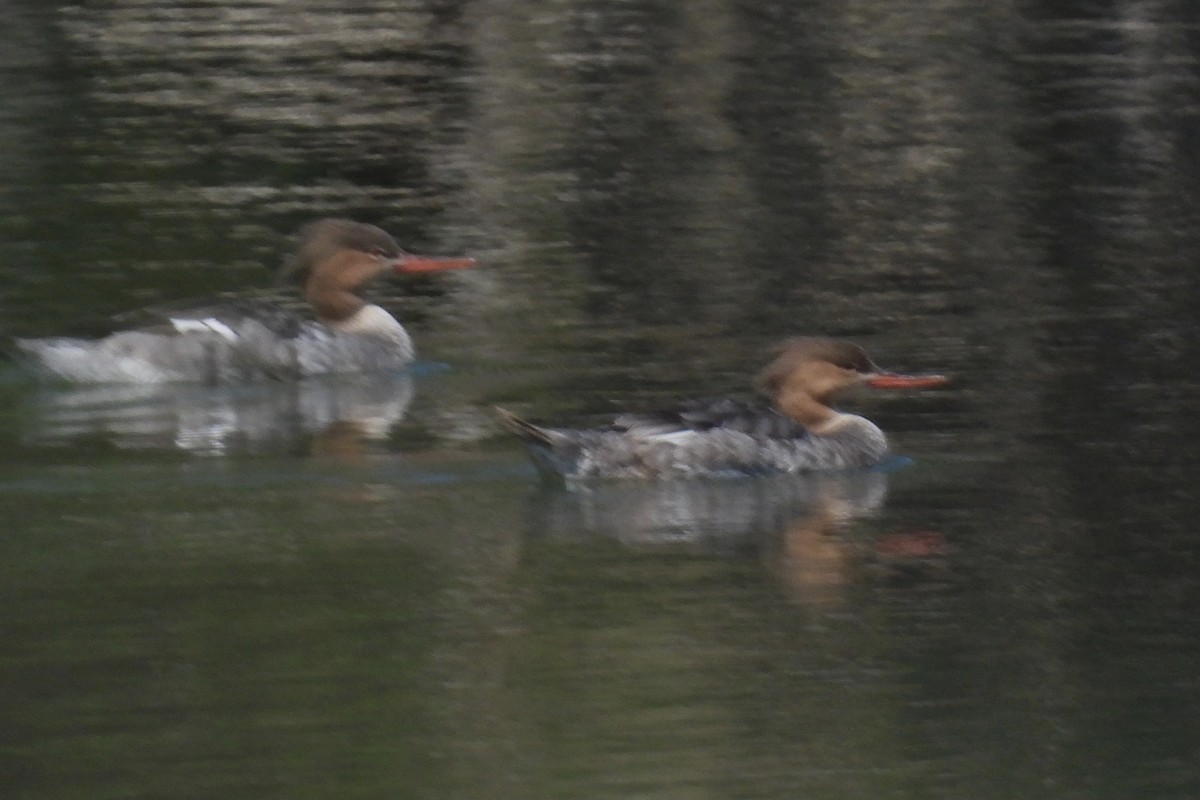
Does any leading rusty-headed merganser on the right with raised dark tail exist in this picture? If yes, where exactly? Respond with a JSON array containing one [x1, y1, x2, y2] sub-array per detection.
[[497, 338, 948, 480]]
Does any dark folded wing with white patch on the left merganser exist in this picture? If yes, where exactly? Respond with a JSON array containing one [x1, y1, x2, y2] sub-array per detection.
[[112, 297, 308, 338]]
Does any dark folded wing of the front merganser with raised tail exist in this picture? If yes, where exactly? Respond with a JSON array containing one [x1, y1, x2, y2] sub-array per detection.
[[612, 398, 808, 439]]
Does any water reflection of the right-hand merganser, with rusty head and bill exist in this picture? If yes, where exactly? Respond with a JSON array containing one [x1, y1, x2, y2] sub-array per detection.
[[534, 470, 946, 610]]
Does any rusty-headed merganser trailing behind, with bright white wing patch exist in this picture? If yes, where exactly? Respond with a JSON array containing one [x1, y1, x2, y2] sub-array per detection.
[[17, 219, 475, 384]]
